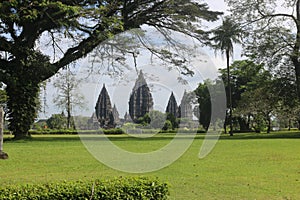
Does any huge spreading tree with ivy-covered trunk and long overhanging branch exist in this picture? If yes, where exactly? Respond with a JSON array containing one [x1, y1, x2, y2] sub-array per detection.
[[0, 0, 221, 138]]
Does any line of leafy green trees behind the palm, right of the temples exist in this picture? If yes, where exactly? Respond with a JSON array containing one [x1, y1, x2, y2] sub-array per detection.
[[195, 60, 300, 132]]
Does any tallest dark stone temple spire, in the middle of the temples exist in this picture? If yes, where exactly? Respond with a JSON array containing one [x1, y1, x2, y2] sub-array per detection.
[[129, 70, 153, 122]]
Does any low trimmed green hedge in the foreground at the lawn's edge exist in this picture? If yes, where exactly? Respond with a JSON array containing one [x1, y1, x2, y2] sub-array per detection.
[[0, 178, 169, 200]]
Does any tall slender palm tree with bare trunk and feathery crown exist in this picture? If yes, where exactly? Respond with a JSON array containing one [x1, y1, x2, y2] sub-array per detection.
[[211, 17, 242, 136]]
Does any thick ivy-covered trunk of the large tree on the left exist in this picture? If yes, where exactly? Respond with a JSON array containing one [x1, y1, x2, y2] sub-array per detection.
[[6, 77, 39, 139]]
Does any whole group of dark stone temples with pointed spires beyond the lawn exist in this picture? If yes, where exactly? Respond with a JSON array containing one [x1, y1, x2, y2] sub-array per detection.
[[92, 71, 193, 128]]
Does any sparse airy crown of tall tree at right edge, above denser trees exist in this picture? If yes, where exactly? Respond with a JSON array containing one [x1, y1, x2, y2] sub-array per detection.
[[225, 0, 300, 98]]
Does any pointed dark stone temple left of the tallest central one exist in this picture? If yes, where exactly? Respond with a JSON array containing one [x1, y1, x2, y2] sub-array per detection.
[[95, 84, 119, 128]]
